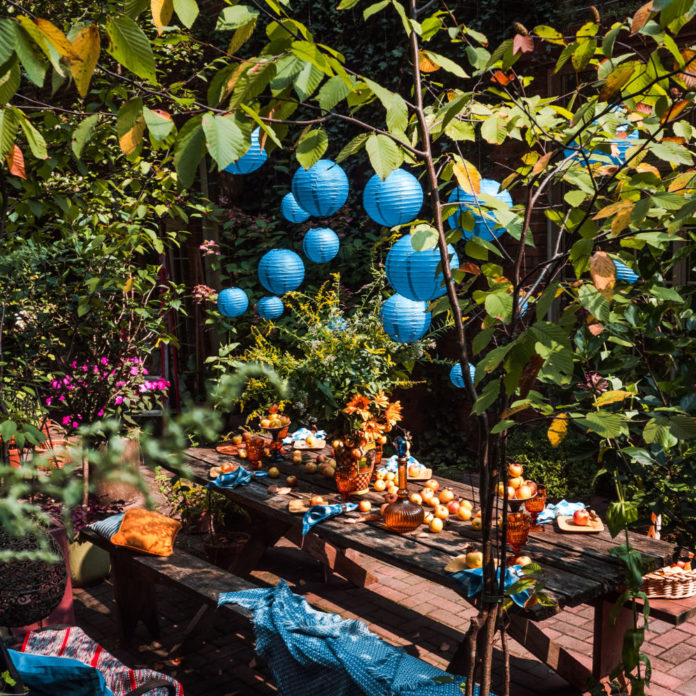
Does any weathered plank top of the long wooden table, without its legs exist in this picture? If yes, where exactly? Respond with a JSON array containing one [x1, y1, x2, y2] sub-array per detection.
[[181, 448, 675, 619]]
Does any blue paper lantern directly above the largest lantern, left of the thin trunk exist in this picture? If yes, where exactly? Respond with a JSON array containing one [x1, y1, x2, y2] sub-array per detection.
[[363, 169, 423, 227]]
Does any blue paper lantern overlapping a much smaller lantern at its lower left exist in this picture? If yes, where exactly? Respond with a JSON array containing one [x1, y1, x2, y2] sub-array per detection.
[[292, 160, 348, 217]]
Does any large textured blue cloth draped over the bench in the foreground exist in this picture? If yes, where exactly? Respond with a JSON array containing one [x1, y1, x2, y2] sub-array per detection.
[[218, 580, 478, 696]]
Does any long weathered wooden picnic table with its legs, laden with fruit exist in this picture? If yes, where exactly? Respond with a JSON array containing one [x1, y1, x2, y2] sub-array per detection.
[[179, 448, 696, 690]]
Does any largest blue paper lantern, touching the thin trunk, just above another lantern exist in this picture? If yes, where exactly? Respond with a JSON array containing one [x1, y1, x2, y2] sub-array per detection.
[[386, 234, 459, 302]]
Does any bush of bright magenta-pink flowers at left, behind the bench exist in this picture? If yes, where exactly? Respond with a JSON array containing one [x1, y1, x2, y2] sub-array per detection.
[[45, 357, 170, 429]]
